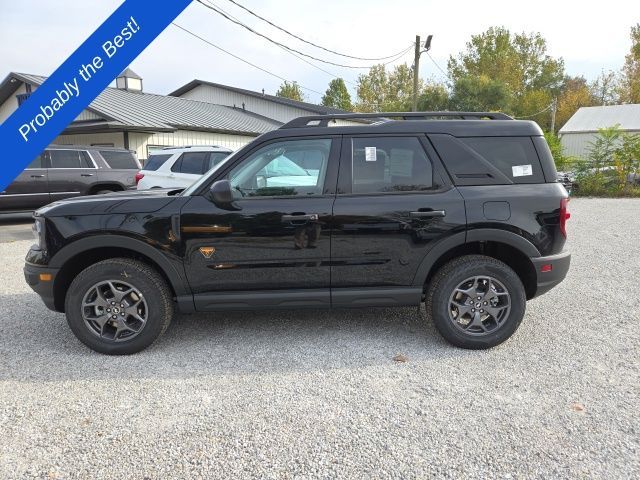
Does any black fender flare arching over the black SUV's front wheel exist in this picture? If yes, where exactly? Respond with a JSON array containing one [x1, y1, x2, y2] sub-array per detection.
[[49, 235, 191, 297]]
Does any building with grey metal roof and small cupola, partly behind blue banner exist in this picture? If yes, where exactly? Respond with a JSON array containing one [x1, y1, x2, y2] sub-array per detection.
[[0, 69, 282, 159]]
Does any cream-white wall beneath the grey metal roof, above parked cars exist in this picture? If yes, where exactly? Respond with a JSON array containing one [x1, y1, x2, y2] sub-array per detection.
[[129, 130, 255, 160]]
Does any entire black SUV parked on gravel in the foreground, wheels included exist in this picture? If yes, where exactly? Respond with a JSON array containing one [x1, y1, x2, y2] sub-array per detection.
[[25, 112, 570, 354]]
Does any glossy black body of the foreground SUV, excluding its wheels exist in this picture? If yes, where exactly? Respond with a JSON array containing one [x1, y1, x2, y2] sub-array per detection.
[[25, 112, 570, 312]]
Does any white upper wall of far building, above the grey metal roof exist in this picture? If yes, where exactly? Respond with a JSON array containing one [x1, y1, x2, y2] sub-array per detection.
[[176, 85, 314, 123]]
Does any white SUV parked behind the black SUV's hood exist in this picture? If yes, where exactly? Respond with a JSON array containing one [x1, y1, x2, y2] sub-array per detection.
[[136, 146, 233, 190]]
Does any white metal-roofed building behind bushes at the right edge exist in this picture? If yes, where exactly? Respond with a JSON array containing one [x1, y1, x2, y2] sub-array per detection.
[[558, 104, 640, 158]]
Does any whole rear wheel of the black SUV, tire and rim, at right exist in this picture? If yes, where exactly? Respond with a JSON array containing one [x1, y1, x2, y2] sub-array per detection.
[[426, 255, 526, 349]]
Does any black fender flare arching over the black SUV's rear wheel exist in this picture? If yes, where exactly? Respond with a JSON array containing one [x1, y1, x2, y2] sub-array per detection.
[[412, 228, 540, 286]]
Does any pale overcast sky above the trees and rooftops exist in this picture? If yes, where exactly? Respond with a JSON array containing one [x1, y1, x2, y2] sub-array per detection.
[[0, 0, 640, 102]]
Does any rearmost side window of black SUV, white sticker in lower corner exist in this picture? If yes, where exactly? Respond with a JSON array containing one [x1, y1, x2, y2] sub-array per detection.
[[459, 137, 545, 183]]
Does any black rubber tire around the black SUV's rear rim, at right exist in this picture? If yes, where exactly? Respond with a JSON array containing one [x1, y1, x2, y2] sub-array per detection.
[[425, 255, 526, 350]]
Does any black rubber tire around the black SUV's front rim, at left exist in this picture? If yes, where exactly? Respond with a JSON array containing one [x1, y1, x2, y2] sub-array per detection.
[[65, 258, 173, 355]]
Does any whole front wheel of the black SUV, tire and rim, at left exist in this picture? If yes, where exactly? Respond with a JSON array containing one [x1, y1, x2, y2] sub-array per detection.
[[65, 258, 173, 355]]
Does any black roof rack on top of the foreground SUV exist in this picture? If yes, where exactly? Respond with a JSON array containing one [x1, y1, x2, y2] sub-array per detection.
[[280, 111, 513, 129]]
